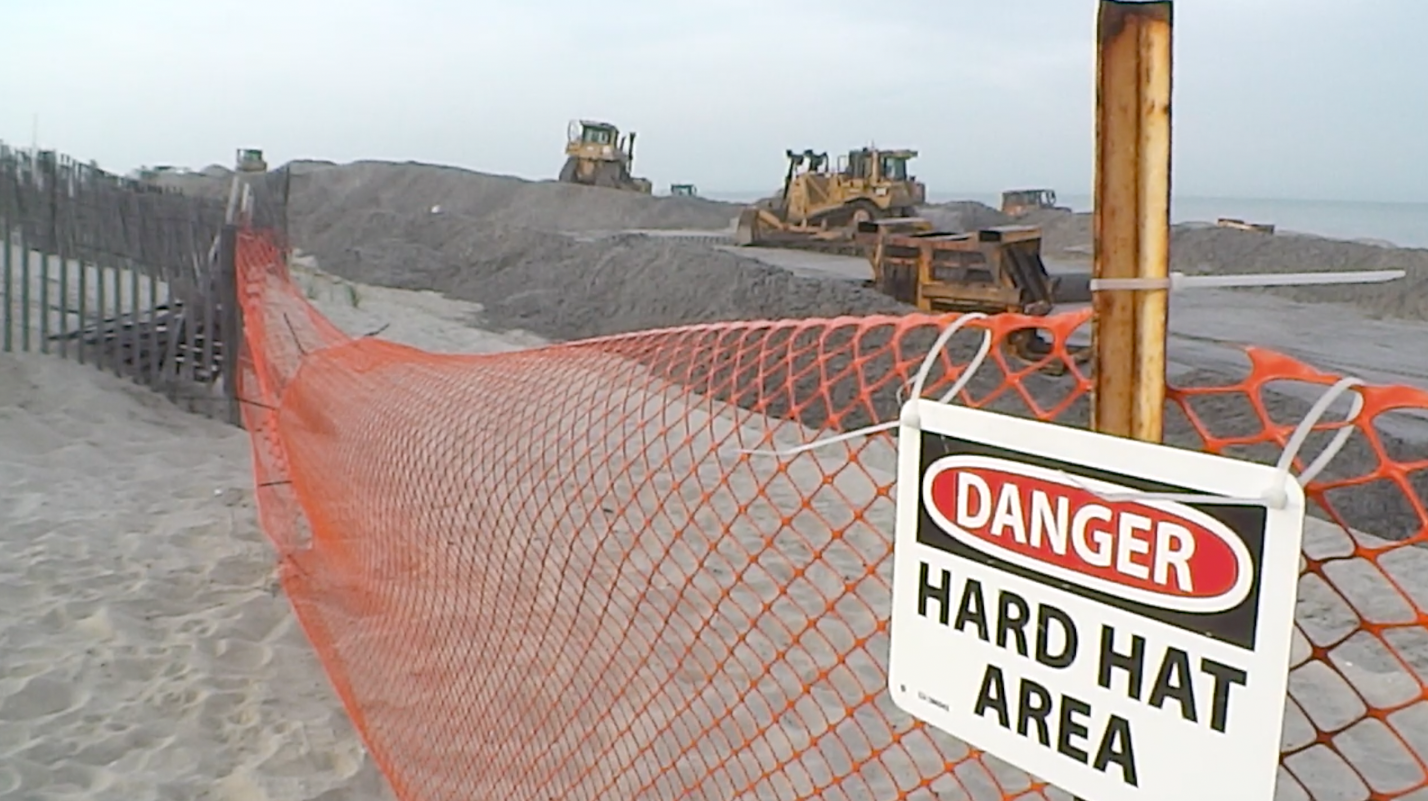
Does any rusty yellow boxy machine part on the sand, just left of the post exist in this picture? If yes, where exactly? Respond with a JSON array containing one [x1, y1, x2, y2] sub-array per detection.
[[854, 221, 1088, 373]]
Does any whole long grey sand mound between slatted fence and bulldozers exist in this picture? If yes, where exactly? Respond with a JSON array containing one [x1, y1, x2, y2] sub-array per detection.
[[291, 164, 905, 338]]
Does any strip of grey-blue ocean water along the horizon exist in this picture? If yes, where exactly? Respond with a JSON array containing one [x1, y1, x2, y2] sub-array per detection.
[[705, 191, 1428, 248]]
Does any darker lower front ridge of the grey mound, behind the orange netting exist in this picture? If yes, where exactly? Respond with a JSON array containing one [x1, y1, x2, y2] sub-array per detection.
[[313, 225, 910, 340]]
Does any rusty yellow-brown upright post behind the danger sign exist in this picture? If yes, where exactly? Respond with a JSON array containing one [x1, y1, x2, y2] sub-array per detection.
[[1091, 0, 1172, 441]]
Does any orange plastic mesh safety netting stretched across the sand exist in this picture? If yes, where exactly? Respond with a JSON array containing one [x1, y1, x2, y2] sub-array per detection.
[[238, 234, 1428, 801]]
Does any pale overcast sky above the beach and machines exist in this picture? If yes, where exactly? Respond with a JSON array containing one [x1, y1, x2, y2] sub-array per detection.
[[8, 0, 1428, 201]]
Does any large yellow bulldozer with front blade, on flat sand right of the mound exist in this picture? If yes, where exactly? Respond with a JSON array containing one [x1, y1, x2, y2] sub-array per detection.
[[735, 147, 932, 256]]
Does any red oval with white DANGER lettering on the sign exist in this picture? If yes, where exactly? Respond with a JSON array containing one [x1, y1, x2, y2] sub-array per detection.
[[925, 457, 1252, 611]]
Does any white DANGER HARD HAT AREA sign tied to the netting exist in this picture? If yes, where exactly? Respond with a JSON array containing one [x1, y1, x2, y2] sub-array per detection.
[[888, 401, 1304, 801]]
